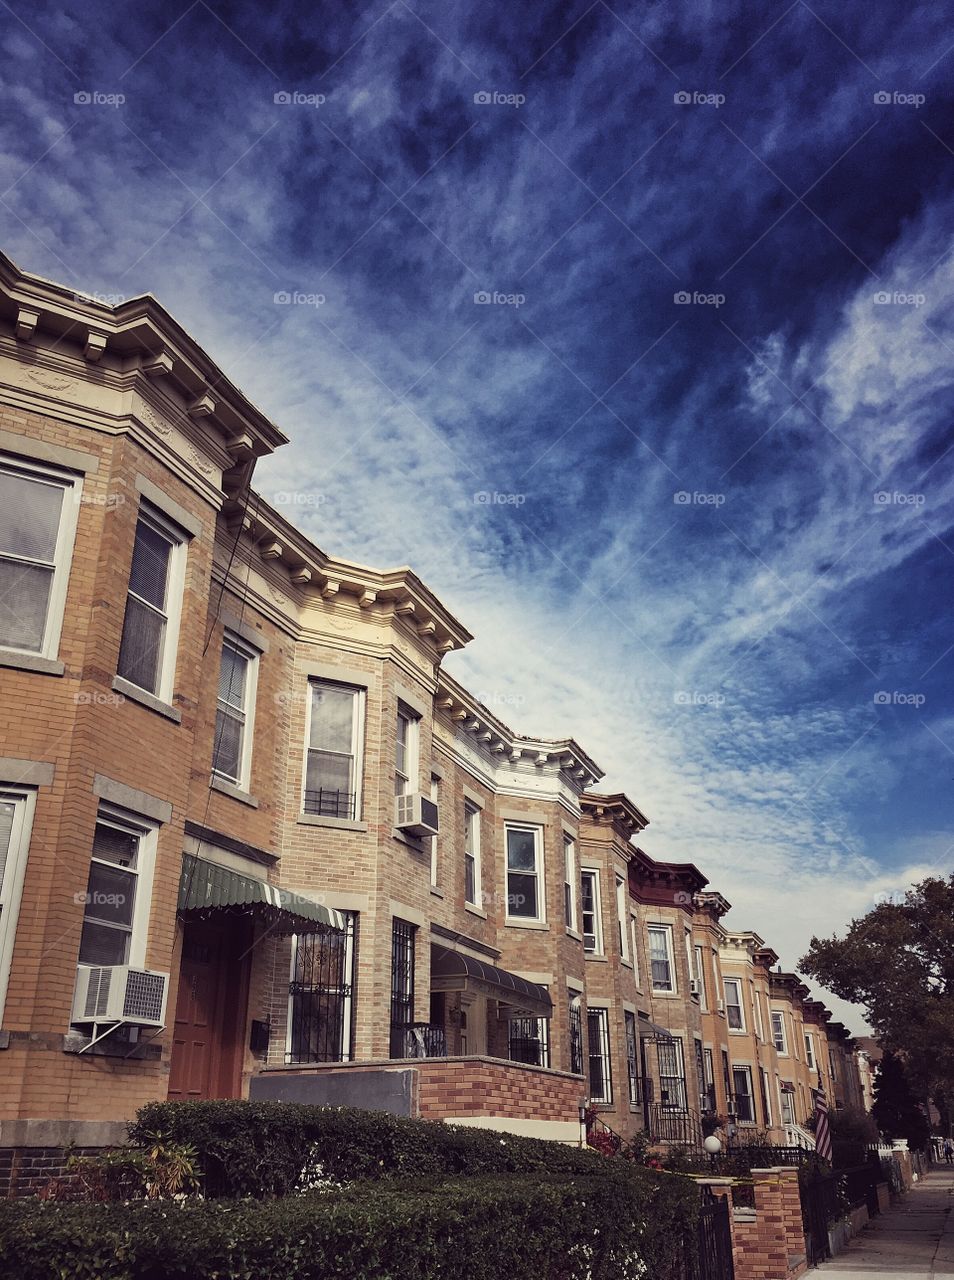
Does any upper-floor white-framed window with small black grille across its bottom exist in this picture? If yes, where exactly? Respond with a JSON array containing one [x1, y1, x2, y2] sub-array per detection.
[[303, 680, 365, 818]]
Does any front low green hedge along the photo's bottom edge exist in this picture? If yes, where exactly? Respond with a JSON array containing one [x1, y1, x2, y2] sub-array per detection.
[[0, 1160, 698, 1280]]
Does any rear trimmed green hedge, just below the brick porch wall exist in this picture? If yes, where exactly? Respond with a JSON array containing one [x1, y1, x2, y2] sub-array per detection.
[[129, 1101, 606, 1197]]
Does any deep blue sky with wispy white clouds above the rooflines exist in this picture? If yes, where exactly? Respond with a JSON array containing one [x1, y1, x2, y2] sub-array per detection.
[[0, 0, 954, 1025]]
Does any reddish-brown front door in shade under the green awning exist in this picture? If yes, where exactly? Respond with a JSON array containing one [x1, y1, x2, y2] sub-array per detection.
[[169, 922, 247, 1101]]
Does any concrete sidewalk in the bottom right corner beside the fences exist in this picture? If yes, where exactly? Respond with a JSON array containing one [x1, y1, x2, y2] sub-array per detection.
[[809, 1165, 954, 1280]]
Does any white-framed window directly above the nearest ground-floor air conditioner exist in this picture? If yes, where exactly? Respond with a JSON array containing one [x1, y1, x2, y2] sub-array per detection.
[[79, 805, 155, 965]]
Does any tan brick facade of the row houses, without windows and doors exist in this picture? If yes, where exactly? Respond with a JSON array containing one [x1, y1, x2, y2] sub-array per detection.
[[0, 247, 865, 1181]]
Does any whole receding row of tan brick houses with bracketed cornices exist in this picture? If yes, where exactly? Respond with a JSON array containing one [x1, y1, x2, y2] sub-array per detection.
[[0, 247, 852, 1172]]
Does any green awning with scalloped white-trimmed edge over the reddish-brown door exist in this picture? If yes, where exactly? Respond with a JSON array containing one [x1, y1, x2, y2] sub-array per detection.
[[179, 854, 344, 933]]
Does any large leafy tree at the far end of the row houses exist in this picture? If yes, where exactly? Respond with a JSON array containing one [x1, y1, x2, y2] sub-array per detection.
[[800, 876, 954, 1097]]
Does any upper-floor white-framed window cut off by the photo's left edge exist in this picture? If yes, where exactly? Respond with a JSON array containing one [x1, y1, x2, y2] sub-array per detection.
[[0, 458, 81, 658]]
